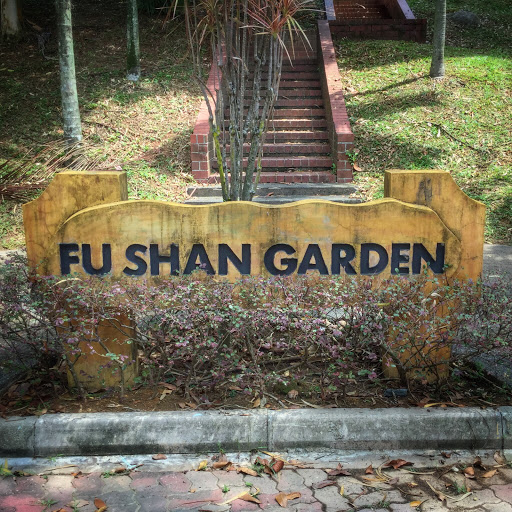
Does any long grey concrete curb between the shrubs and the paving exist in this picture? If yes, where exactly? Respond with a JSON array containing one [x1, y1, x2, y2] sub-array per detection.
[[0, 407, 512, 457]]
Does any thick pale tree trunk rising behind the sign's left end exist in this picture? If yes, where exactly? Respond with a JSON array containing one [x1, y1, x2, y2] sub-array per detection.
[[56, 0, 82, 142]]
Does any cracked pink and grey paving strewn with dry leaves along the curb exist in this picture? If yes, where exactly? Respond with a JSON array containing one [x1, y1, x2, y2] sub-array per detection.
[[0, 454, 512, 512]]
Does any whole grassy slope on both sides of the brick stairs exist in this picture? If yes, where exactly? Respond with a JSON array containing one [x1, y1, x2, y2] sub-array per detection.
[[0, 0, 512, 249]]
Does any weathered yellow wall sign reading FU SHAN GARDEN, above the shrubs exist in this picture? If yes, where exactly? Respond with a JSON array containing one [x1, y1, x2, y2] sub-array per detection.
[[24, 171, 484, 280]]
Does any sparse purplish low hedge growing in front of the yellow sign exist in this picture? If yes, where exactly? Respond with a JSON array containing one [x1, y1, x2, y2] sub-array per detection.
[[0, 261, 512, 398]]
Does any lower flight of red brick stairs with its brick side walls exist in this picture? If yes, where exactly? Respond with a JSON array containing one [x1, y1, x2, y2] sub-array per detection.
[[191, 21, 353, 184]]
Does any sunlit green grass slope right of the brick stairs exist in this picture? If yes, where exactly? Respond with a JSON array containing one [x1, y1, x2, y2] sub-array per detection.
[[336, 0, 512, 243]]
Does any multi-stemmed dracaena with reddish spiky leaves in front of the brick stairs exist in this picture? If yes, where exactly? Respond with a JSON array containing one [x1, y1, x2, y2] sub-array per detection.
[[185, 0, 312, 201]]
